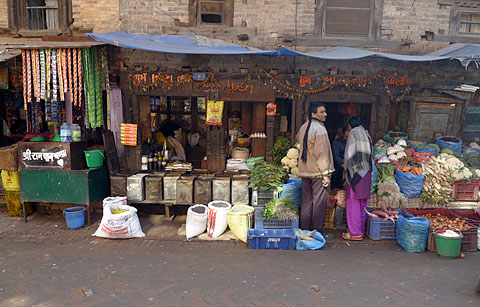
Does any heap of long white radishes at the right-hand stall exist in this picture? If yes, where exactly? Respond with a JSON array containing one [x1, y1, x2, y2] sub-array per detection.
[[421, 155, 453, 204]]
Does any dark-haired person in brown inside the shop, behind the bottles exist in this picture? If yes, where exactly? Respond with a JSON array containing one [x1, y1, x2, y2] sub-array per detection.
[[155, 121, 187, 161]]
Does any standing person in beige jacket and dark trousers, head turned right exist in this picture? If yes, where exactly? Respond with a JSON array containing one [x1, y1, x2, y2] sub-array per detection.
[[297, 102, 335, 239]]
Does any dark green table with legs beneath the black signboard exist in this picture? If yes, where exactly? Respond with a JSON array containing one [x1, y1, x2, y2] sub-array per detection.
[[20, 167, 110, 225]]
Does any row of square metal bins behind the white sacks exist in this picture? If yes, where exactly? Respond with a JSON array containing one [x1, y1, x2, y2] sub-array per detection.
[[111, 173, 250, 205]]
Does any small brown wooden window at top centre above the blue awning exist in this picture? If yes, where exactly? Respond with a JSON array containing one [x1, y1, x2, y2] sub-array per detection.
[[190, 0, 233, 27]]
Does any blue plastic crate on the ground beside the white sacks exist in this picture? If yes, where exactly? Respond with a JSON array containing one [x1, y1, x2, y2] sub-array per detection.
[[248, 229, 297, 249]]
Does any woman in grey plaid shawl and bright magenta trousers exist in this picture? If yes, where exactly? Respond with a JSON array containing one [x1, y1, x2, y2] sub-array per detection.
[[342, 116, 373, 241]]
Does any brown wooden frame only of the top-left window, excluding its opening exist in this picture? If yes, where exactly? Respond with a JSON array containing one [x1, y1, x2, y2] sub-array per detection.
[[7, 0, 73, 37]]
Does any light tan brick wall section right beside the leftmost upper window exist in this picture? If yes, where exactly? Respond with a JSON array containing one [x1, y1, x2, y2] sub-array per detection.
[[72, 0, 121, 33]]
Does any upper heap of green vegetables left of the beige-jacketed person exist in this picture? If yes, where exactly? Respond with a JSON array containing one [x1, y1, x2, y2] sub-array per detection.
[[248, 162, 288, 193]]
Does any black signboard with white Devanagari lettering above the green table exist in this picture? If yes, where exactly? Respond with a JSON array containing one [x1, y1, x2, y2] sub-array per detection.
[[18, 142, 87, 170]]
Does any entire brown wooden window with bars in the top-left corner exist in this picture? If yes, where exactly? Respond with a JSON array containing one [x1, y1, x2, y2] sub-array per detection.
[[8, 0, 73, 36]]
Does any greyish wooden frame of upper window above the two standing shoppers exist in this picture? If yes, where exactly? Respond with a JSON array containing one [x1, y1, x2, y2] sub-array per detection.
[[314, 0, 383, 40]]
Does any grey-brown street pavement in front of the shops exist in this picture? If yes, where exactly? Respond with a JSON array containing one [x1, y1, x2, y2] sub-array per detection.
[[0, 212, 480, 306]]
